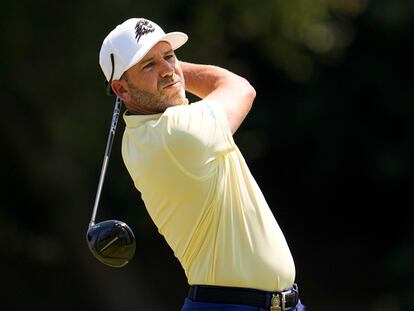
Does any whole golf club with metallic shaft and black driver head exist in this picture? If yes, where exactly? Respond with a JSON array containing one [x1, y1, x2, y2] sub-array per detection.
[[86, 97, 136, 268]]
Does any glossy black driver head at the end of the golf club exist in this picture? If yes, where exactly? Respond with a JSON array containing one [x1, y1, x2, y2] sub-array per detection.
[[86, 220, 136, 268]]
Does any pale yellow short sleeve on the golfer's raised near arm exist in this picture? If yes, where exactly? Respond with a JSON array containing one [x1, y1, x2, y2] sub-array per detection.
[[160, 100, 235, 178]]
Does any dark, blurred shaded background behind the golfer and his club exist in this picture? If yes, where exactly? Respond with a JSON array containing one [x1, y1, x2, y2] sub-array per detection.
[[0, 0, 414, 311]]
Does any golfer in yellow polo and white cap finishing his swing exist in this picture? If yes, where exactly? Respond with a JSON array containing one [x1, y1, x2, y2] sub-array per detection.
[[100, 18, 304, 311]]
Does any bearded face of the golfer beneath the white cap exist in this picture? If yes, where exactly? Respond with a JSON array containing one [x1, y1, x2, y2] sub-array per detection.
[[121, 41, 188, 114]]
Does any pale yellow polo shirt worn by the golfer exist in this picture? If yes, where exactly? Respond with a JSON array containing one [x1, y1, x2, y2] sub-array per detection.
[[122, 100, 295, 290]]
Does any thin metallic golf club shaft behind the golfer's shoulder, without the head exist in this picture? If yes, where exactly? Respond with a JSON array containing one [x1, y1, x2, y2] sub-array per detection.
[[89, 97, 122, 226]]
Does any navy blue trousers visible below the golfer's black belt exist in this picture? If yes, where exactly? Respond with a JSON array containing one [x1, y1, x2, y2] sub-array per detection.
[[181, 298, 306, 311]]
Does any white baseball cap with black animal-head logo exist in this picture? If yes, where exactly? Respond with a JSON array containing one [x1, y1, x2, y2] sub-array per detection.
[[99, 18, 188, 81]]
